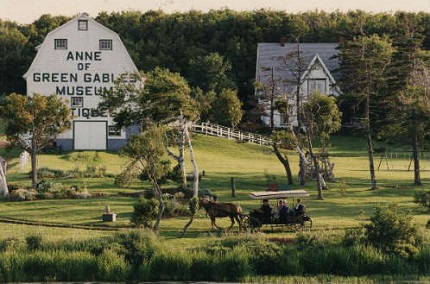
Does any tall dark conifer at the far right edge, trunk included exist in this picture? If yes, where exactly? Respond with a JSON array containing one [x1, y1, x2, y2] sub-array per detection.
[[384, 13, 430, 185]]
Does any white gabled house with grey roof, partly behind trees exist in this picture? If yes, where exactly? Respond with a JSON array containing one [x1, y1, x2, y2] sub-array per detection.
[[255, 43, 340, 127]]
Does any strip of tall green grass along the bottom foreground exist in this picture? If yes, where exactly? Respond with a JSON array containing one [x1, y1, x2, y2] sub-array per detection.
[[0, 231, 430, 282]]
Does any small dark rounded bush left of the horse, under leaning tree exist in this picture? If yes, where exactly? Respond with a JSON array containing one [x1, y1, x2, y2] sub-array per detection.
[[130, 198, 158, 228]]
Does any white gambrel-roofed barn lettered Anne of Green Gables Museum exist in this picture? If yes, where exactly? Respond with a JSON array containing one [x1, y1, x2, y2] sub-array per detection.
[[24, 13, 138, 150]]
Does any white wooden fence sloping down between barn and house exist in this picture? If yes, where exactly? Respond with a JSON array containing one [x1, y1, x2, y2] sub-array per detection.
[[191, 122, 272, 145]]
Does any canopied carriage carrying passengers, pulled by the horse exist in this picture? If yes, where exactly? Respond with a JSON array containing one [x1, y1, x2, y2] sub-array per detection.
[[242, 189, 312, 232]]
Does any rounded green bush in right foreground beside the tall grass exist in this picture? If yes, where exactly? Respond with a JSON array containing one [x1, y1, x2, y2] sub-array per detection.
[[364, 204, 420, 256]]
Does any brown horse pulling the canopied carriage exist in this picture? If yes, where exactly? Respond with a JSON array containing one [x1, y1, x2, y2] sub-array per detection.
[[199, 198, 242, 231]]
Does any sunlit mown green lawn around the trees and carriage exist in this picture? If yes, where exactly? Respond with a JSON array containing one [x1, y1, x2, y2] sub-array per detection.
[[0, 135, 430, 244]]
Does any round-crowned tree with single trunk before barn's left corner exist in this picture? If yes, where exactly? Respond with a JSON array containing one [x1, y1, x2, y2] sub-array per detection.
[[0, 93, 72, 189]]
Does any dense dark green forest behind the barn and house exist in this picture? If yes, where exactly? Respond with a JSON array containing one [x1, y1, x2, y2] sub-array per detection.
[[0, 9, 430, 106]]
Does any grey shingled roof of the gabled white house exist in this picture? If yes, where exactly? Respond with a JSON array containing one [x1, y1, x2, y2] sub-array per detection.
[[255, 43, 339, 87]]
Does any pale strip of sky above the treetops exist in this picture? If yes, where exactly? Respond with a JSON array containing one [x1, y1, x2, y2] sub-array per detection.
[[0, 0, 430, 24]]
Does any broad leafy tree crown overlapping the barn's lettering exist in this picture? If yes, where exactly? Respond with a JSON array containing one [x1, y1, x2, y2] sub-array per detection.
[[100, 68, 198, 128]]
